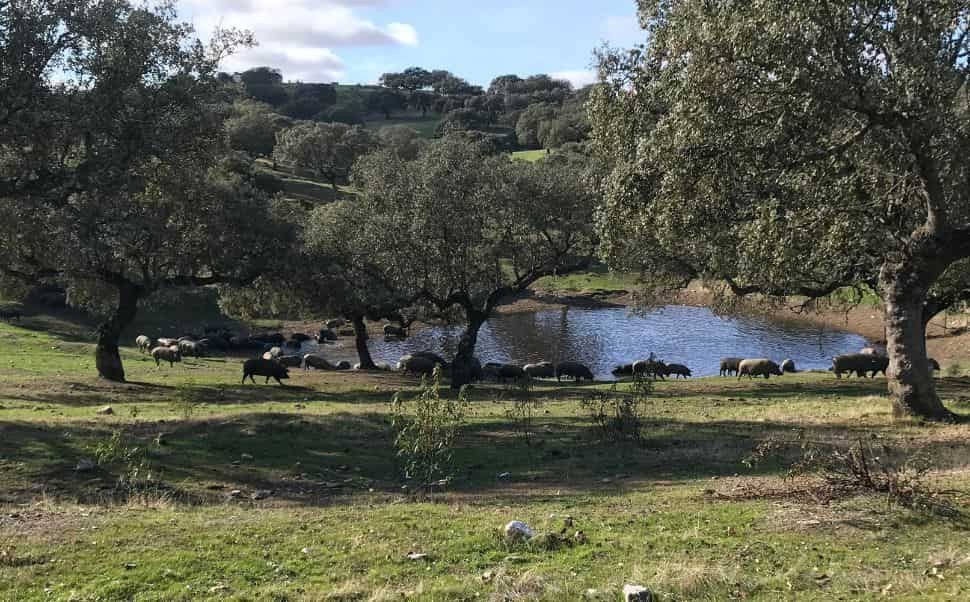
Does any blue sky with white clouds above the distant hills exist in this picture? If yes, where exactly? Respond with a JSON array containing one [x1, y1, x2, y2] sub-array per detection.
[[178, 0, 643, 86]]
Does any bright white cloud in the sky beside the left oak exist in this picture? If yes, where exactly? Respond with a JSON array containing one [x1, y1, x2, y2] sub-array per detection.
[[179, 0, 419, 82]]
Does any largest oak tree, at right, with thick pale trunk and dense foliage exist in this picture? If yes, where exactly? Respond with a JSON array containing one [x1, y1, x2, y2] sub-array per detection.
[[591, 0, 970, 420]]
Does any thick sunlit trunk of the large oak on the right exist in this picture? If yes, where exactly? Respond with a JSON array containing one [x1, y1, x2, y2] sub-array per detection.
[[881, 269, 956, 421]]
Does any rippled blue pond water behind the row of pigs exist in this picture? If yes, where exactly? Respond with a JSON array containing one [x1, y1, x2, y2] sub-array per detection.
[[360, 305, 867, 380]]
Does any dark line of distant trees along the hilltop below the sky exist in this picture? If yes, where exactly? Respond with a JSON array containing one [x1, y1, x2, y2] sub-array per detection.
[[219, 67, 591, 156]]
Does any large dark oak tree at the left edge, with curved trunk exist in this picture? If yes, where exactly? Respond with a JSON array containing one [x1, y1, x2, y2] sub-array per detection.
[[0, 0, 285, 380]]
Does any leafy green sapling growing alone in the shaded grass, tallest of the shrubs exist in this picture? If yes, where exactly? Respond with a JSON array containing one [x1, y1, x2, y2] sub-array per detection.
[[391, 366, 468, 492]]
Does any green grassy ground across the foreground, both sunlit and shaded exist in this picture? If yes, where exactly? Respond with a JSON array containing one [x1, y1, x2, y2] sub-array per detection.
[[0, 317, 970, 601]]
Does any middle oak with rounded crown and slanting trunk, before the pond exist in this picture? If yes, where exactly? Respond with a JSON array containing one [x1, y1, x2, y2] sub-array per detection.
[[353, 135, 596, 386]]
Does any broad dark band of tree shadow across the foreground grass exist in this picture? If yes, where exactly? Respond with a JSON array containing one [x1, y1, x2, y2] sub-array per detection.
[[0, 412, 970, 506]]
